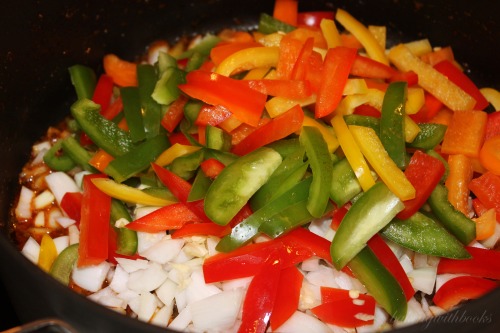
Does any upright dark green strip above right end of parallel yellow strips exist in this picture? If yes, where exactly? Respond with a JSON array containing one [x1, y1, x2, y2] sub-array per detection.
[[380, 81, 408, 169]]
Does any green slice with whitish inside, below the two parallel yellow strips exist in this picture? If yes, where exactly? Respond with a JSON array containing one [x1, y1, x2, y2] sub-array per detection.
[[330, 182, 404, 270]]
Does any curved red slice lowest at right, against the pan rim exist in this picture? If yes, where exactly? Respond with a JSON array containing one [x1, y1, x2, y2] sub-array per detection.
[[432, 276, 498, 310]]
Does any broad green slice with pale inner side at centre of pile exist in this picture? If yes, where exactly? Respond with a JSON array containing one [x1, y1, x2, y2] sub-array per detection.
[[205, 147, 282, 225]]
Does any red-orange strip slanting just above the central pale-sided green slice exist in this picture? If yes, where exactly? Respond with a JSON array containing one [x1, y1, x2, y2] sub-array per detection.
[[232, 104, 304, 156]]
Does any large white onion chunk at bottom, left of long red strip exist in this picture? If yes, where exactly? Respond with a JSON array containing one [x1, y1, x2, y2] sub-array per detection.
[[190, 289, 243, 331]]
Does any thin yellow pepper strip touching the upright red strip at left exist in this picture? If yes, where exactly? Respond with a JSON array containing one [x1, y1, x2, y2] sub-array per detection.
[[92, 178, 174, 207]]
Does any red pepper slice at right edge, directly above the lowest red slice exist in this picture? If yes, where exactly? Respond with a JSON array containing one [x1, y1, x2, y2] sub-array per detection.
[[437, 246, 500, 280]]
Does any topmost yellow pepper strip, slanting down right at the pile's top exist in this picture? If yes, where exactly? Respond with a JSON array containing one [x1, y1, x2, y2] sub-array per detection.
[[335, 8, 389, 65]]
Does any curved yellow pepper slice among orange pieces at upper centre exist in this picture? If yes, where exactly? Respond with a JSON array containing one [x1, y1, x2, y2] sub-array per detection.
[[215, 46, 279, 76]]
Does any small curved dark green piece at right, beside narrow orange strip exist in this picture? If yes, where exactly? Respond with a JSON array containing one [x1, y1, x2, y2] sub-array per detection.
[[427, 184, 476, 245]]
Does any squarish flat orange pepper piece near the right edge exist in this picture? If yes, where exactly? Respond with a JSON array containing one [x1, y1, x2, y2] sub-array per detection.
[[441, 107, 488, 158]]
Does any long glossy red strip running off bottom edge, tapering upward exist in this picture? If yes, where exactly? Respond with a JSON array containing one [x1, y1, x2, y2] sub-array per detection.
[[238, 249, 284, 333]]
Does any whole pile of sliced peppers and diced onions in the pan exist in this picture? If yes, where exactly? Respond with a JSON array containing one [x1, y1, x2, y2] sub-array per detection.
[[13, 0, 500, 332]]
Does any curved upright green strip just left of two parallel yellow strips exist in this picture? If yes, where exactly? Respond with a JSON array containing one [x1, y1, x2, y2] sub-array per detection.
[[299, 126, 333, 218]]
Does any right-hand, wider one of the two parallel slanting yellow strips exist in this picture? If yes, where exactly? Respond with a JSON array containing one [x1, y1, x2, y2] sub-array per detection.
[[348, 125, 415, 201]]
